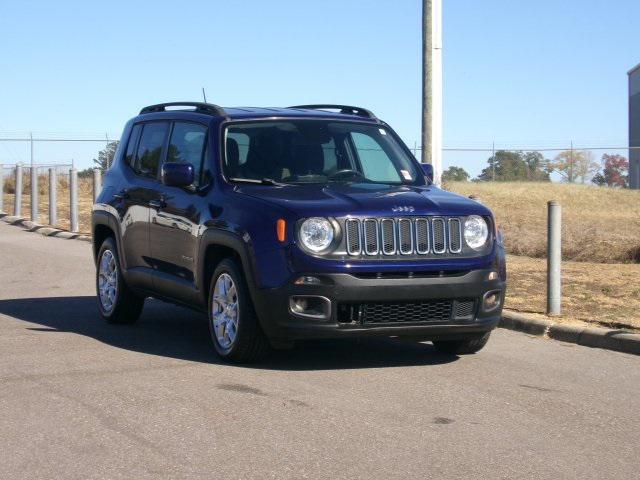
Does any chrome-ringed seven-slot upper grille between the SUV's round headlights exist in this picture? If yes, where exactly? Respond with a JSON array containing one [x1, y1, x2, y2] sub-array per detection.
[[344, 217, 462, 256]]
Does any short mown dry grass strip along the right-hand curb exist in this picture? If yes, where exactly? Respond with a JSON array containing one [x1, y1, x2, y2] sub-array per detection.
[[505, 255, 640, 330]]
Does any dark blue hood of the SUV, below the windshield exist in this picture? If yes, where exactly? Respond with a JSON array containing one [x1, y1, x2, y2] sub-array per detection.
[[236, 183, 491, 217]]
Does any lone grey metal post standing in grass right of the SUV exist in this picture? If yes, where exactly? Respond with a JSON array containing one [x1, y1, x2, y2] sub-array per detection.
[[547, 201, 562, 315]]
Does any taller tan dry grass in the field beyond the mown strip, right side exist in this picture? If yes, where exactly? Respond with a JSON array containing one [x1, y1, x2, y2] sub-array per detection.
[[447, 182, 640, 263]]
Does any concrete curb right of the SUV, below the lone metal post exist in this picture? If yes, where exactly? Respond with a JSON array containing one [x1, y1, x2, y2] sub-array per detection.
[[500, 311, 640, 355]]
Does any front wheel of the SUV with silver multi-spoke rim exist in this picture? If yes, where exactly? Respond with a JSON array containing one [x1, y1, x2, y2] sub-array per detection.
[[208, 258, 269, 363]]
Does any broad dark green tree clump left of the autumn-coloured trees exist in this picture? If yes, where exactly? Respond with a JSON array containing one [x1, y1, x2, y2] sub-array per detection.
[[478, 150, 549, 182]]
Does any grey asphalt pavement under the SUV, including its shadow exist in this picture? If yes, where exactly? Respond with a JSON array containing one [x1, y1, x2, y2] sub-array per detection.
[[0, 222, 640, 479]]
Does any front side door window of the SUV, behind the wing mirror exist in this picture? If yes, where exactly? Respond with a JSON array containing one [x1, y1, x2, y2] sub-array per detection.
[[167, 122, 207, 187]]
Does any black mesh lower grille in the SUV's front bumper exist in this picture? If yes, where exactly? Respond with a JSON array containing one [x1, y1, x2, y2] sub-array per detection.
[[338, 299, 475, 325]]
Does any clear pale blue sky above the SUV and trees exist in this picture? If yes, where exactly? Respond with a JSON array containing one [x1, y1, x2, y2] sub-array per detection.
[[0, 0, 640, 174]]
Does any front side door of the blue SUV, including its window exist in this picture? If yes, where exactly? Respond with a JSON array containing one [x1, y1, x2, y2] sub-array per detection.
[[149, 121, 208, 301]]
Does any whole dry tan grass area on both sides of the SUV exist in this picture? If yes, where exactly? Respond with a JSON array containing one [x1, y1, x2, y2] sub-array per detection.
[[4, 179, 640, 330]]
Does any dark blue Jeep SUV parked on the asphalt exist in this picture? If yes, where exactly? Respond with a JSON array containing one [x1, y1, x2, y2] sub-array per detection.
[[92, 102, 506, 361]]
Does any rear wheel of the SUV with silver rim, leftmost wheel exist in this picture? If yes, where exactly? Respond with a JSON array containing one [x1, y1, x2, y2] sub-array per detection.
[[96, 237, 144, 324]]
